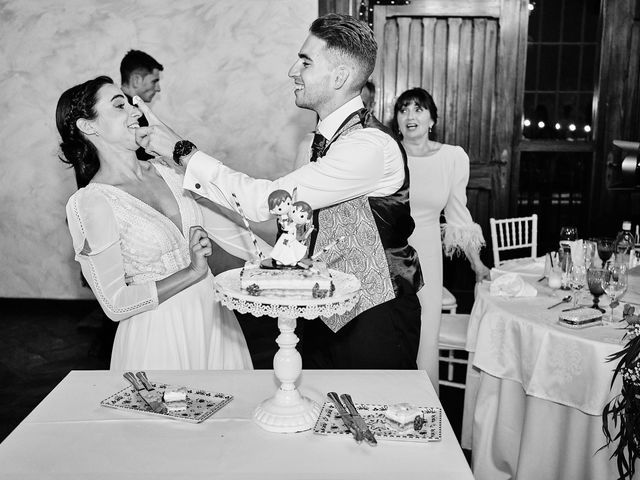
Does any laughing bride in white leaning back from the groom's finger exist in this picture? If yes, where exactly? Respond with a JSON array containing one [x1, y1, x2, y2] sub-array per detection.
[[56, 76, 260, 370]]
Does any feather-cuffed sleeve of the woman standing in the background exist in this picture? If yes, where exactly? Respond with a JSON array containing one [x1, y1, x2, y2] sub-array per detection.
[[441, 147, 485, 257]]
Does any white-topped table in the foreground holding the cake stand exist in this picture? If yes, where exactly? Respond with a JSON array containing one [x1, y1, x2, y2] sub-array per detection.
[[0, 370, 473, 480]]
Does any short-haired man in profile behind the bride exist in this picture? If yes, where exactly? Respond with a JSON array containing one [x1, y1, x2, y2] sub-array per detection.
[[120, 50, 164, 160]]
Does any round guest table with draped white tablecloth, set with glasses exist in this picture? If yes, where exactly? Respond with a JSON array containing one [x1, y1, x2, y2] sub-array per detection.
[[461, 259, 640, 480]]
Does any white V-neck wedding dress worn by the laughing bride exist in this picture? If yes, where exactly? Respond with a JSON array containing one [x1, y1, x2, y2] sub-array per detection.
[[67, 159, 252, 370]]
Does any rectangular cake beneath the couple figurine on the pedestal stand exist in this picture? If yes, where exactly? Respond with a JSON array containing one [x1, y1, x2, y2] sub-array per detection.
[[240, 262, 335, 298]]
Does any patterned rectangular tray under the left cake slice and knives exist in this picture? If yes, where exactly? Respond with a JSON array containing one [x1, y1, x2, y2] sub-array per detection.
[[100, 382, 233, 423]]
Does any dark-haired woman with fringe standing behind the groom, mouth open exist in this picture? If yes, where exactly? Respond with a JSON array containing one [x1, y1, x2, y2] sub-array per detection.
[[391, 88, 489, 391]]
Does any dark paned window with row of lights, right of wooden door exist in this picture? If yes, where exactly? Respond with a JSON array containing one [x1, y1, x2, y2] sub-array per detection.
[[517, 0, 600, 253]]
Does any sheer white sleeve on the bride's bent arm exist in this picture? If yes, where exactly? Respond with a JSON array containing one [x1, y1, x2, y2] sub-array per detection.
[[67, 190, 158, 321]]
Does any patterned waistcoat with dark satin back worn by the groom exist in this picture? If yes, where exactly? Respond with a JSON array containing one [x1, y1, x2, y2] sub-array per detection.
[[311, 109, 423, 332]]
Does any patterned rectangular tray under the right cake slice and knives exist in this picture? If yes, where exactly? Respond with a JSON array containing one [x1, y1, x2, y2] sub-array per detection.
[[313, 402, 442, 442]]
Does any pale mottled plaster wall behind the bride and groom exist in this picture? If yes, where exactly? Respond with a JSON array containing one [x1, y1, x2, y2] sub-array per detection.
[[0, 0, 318, 299]]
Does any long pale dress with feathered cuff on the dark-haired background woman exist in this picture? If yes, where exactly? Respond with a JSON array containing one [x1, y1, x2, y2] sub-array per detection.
[[407, 144, 484, 390]]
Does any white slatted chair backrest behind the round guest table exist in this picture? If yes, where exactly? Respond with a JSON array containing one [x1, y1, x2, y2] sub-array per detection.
[[489, 213, 538, 267]]
